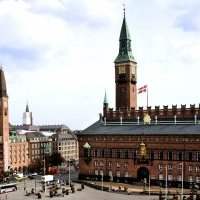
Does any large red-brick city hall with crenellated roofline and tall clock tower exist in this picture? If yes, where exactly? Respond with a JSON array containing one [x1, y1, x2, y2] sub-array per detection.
[[78, 12, 200, 186]]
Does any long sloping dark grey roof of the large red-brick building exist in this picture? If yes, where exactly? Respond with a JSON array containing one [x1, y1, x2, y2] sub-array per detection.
[[77, 121, 200, 135]]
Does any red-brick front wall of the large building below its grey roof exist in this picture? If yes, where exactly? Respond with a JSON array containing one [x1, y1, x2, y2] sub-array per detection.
[[79, 135, 200, 187]]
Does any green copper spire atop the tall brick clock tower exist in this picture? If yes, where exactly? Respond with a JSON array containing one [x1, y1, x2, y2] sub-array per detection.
[[115, 15, 135, 63]]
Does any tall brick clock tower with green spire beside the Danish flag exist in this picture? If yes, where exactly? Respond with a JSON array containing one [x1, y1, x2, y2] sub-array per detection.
[[115, 12, 137, 110]]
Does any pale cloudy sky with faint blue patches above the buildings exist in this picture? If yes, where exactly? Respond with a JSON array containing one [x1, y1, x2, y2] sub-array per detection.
[[0, 0, 200, 129]]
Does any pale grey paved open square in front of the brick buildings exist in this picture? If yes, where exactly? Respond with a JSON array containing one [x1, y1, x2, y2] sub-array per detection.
[[0, 180, 158, 200]]
